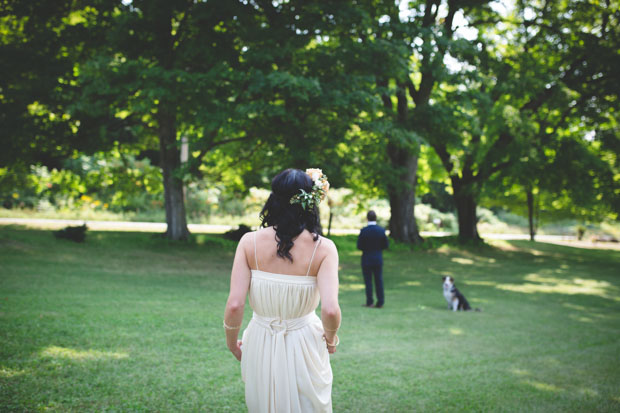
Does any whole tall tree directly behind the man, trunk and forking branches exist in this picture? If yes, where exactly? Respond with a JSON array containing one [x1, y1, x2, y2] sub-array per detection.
[[336, 0, 496, 242]]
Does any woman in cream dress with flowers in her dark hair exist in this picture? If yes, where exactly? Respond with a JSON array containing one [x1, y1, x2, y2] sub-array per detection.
[[224, 169, 340, 412]]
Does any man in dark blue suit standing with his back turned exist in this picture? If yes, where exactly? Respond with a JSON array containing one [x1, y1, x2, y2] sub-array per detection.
[[357, 211, 389, 308]]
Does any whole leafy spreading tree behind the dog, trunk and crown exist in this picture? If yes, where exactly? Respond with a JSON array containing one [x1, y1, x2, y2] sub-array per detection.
[[427, 0, 618, 240]]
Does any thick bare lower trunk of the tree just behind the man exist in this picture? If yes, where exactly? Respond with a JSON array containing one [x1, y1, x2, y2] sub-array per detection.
[[388, 153, 424, 244]]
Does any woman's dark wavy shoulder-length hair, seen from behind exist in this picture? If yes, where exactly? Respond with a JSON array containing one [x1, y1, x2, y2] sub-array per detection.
[[260, 169, 321, 262]]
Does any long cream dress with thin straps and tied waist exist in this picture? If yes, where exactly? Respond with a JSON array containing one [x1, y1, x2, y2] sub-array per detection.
[[241, 234, 332, 413]]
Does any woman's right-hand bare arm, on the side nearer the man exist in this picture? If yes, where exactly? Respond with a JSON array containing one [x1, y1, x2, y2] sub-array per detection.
[[317, 239, 341, 353]]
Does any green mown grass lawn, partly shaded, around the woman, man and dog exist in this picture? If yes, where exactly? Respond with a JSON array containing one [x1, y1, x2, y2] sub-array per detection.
[[0, 227, 620, 412]]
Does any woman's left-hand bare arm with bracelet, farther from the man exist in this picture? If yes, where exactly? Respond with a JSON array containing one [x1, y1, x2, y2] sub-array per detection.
[[224, 233, 251, 361]]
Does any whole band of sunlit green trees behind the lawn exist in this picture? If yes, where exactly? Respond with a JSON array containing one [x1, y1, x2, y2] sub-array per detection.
[[0, 0, 620, 242]]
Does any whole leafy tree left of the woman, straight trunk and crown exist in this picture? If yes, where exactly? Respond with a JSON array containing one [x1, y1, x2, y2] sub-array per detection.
[[71, 1, 252, 240]]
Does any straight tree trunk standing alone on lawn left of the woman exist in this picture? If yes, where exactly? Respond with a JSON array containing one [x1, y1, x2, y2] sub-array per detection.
[[158, 108, 189, 241]]
